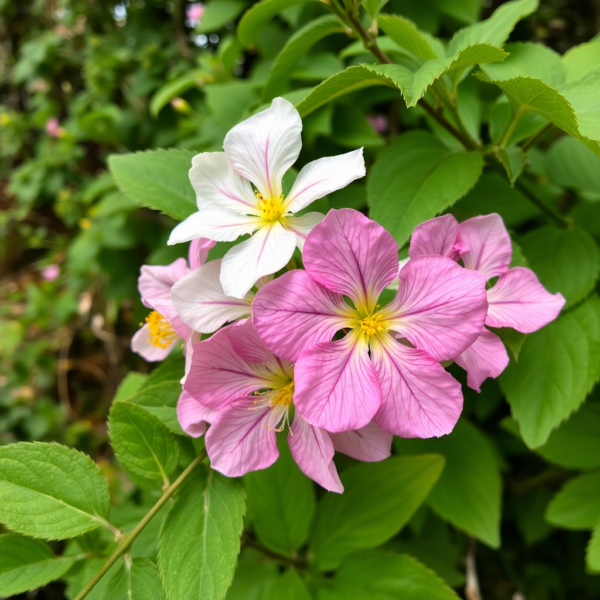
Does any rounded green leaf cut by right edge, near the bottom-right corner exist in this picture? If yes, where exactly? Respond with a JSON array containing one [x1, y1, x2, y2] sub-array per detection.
[[546, 471, 600, 529]]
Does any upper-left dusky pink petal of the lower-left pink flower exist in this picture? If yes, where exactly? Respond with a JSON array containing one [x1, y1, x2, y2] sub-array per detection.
[[184, 326, 272, 410]]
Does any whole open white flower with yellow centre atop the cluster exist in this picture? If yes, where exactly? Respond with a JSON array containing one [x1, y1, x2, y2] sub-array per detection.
[[169, 98, 365, 299]]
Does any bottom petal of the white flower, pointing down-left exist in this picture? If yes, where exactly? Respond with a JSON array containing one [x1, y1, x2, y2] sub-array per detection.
[[221, 223, 296, 298]]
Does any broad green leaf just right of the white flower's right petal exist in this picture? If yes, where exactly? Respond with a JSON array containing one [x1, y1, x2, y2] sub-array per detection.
[[367, 131, 483, 246]]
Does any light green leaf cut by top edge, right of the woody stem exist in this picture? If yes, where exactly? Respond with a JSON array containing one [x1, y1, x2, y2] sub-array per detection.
[[448, 0, 538, 54]]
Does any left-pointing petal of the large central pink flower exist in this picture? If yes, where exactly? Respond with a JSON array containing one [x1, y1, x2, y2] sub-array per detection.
[[252, 270, 353, 362]]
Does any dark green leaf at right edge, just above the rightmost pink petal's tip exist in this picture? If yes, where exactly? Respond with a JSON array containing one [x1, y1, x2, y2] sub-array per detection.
[[519, 227, 600, 309]]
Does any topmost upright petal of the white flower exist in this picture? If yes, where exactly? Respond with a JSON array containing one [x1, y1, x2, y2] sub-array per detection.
[[223, 98, 302, 198]]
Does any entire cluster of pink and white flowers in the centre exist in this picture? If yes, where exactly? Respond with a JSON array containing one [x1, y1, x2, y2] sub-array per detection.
[[132, 98, 564, 492]]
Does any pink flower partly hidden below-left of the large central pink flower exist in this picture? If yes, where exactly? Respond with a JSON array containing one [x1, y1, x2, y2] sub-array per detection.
[[184, 320, 392, 492]]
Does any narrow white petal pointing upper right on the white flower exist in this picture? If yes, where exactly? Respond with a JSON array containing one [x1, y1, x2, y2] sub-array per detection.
[[286, 148, 366, 213]]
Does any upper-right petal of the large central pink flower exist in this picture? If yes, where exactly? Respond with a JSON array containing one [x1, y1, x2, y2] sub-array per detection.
[[383, 256, 487, 360]]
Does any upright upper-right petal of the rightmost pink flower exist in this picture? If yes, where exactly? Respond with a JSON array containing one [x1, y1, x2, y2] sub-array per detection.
[[460, 213, 512, 279]]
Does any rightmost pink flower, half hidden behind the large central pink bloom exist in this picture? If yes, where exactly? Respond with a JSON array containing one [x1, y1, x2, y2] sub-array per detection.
[[409, 214, 565, 392]]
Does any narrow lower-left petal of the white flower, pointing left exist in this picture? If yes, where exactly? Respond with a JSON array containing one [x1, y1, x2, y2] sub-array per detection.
[[167, 208, 260, 246]]
